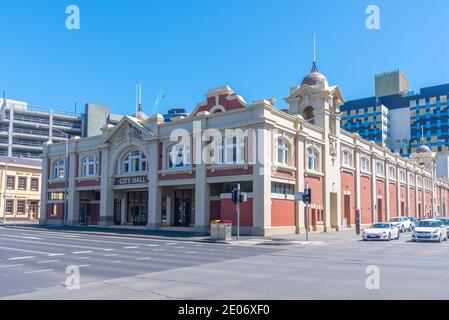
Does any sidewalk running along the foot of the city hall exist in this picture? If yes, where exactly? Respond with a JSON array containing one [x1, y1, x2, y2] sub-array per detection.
[[0, 223, 359, 245]]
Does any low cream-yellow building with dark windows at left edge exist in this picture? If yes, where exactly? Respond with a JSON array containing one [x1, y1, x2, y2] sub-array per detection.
[[0, 156, 42, 221]]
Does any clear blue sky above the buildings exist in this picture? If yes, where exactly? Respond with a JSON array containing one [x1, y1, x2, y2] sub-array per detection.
[[0, 0, 449, 114]]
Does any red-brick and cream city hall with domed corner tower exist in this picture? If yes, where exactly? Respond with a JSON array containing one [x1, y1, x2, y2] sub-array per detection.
[[41, 63, 449, 236]]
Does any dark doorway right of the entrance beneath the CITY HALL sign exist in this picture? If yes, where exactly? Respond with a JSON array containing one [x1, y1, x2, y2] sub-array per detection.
[[174, 190, 195, 227]]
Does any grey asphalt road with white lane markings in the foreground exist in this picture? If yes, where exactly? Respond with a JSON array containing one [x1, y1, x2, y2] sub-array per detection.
[[0, 228, 449, 300]]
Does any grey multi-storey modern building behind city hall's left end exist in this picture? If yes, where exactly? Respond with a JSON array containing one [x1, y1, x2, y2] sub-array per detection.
[[0, 99, 122, 159]]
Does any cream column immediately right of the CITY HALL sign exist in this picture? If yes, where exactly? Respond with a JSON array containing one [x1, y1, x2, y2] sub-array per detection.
[[147, 141, 162, 230]]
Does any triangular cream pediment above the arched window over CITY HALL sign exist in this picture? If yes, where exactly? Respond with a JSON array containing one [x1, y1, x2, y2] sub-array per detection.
[[104, 116, 154, 145]]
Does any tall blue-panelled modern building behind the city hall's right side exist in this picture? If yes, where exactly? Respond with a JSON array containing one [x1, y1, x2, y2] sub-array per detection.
[[341, 71, 449, 177]]
